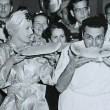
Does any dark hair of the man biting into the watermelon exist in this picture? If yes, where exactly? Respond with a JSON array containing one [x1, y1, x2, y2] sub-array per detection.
[[81, 16, 107, 33]]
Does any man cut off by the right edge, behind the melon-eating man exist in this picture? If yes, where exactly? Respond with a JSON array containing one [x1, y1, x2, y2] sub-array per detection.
[[105, 3, 110, 43]]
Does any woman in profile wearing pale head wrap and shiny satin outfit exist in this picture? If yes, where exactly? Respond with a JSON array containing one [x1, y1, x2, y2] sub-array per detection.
[[0, 10, 54, 110]]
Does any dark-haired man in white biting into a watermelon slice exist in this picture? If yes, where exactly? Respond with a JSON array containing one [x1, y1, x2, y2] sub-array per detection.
[[56, 17, 110, 110]]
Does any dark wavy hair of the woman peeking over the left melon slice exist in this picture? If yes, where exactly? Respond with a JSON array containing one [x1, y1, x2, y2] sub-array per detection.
[[42, 22, 70, 42]]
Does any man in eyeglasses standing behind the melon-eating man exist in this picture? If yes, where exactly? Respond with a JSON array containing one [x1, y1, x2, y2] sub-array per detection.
[[70, 0, 90, 41]]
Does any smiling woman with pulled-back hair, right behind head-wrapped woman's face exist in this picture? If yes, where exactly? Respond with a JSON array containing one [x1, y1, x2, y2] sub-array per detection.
[[33, 12, 50, 45]]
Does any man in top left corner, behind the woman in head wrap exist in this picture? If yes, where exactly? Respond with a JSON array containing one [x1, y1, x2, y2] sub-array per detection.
[[0, 0, 13, 42]]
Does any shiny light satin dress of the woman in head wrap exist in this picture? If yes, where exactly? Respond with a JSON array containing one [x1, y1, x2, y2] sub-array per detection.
[[0, 44, 55, 110]]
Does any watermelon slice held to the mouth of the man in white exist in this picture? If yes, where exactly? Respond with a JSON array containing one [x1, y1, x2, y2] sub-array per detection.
[[70, 43, 110, 60]]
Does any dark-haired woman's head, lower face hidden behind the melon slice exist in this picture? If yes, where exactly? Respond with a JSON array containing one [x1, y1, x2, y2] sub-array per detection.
[[43, 22, 71, 43]]
